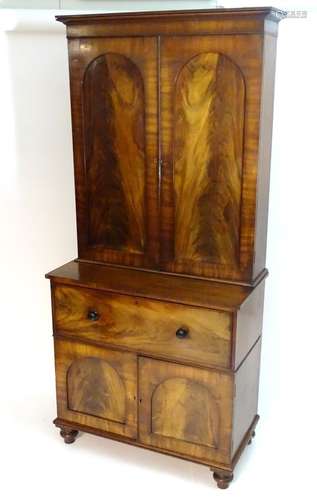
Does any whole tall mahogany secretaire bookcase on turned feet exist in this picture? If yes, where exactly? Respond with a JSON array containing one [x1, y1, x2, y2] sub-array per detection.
[[47, 8, 284, 488]]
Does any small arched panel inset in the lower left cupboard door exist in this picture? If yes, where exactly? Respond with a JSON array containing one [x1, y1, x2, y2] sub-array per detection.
[[67, 357, 126, 423]]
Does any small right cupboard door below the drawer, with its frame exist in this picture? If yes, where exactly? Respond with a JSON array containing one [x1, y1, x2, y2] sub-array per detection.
[[139, 357, 233, 464]]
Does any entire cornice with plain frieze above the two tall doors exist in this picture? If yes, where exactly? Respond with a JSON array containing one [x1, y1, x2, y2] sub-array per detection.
[[57, 7, 286, 38]]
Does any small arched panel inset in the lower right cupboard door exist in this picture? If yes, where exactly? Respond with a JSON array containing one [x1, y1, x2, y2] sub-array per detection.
[[151, 377, 219, 448]]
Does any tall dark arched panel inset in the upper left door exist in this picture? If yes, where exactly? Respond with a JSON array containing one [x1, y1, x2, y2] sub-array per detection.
[[83, 53, 145, 253]]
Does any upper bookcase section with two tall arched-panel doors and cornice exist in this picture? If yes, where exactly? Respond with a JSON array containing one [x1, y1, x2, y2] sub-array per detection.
[[61, 9, 279, 284]]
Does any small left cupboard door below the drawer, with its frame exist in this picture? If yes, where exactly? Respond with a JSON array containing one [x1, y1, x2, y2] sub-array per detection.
[[55, 340, 137, 438]]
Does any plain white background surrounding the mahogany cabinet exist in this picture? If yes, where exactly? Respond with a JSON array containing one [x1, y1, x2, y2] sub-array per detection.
[[0, 2, 317, 500]]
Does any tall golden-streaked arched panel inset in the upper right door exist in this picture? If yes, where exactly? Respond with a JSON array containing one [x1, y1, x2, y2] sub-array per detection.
[[173, 52, 245, 267]]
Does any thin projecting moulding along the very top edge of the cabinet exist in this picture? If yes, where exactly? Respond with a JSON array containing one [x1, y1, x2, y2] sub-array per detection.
[[55, 7, 287, 26]]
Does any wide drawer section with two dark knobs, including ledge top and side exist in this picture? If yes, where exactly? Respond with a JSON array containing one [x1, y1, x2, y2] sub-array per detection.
[[48, 262, 264, 369]]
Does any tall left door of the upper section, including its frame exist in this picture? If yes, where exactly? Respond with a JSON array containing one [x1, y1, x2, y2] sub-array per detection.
[[69, 37, 158, 267]]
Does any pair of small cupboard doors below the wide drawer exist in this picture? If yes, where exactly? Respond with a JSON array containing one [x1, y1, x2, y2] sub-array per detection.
[[55, 339, 233, 464]]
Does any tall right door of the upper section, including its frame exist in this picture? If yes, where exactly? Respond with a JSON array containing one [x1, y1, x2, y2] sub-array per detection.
[[160, 35, 263, 283]]
